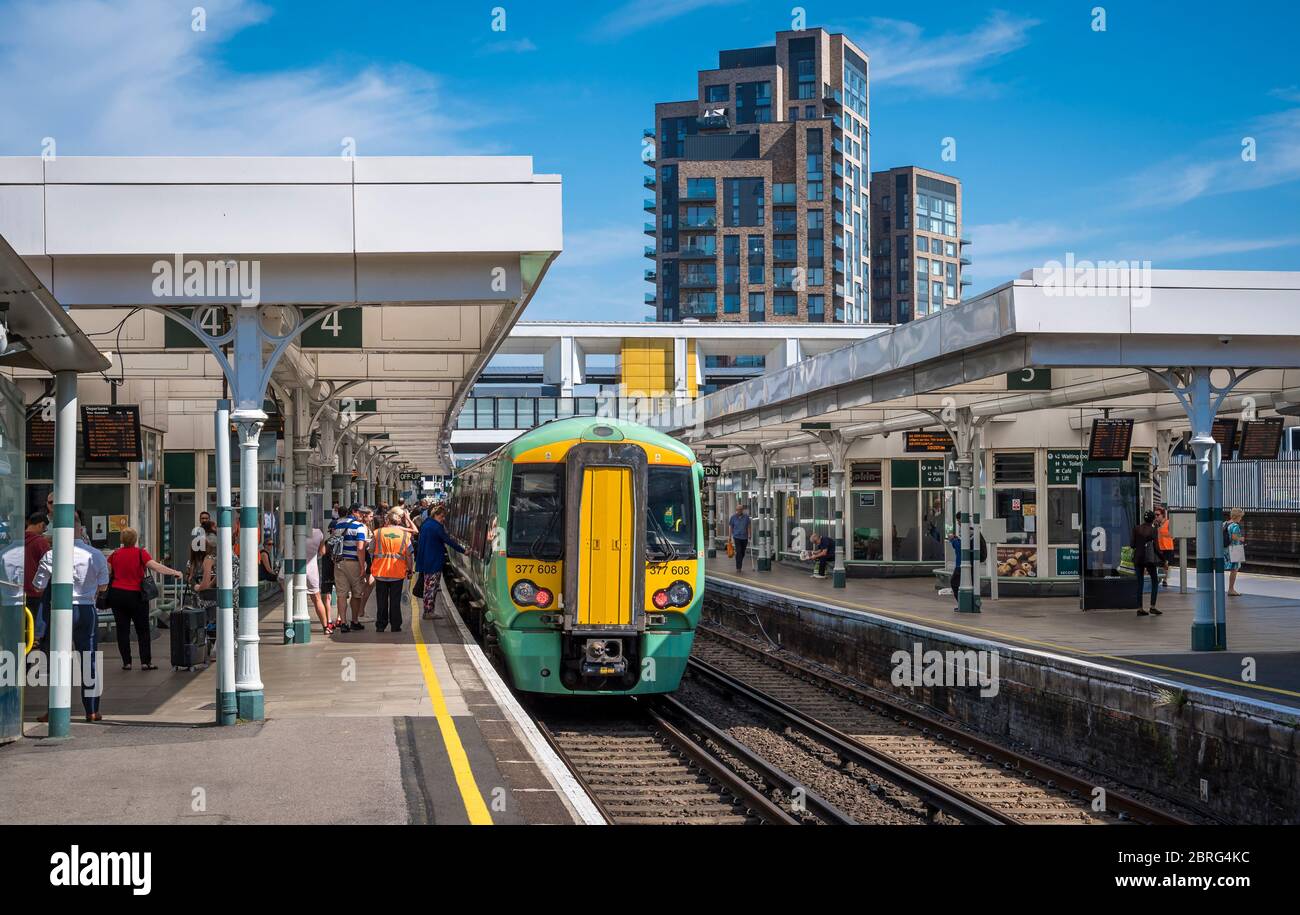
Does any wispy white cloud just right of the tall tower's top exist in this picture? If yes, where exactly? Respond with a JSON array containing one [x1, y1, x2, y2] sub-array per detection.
[[836, 13, 1039, 95]]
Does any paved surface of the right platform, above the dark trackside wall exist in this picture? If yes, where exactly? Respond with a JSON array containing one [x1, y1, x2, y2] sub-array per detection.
[[707, 555, 1300, 708]]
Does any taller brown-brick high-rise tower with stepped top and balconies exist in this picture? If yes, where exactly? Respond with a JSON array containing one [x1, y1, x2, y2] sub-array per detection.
[[645, 29, 871, 322]]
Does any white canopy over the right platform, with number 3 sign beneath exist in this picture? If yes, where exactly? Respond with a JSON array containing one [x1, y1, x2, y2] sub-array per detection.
[[657, 270, 1300, 448]]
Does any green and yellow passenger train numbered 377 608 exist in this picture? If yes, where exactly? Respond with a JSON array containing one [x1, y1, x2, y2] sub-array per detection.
[[447, 417, 705, 695]]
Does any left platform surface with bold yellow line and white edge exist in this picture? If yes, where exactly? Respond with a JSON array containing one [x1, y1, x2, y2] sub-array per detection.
[[0, 593, 592, 825]]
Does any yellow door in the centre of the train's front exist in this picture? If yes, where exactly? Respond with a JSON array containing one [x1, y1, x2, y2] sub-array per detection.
[[577, 467, 634, 626]]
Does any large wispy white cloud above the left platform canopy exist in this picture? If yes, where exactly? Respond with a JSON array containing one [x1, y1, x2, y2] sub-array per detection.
[[0, 0, 483, 156]]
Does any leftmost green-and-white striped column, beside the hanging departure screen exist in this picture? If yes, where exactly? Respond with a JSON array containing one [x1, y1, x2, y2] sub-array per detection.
[[49, 372, 77, 737]]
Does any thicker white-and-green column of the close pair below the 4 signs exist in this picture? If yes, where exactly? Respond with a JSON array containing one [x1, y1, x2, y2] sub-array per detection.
[[234, 409, 267, 721]]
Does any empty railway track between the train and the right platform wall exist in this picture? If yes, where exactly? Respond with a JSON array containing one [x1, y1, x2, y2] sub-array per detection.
[[689, 628, 1186, 825]]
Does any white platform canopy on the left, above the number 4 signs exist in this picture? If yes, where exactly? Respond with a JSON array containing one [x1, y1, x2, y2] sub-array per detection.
[[0, 156, 562, 473]]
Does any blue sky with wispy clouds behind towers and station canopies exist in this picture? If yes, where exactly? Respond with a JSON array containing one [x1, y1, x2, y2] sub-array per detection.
[[0, 0, 1300, 320]]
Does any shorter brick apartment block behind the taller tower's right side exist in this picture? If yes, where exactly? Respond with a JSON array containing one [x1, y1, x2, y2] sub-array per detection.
[[871, 165, 970, 324]]
